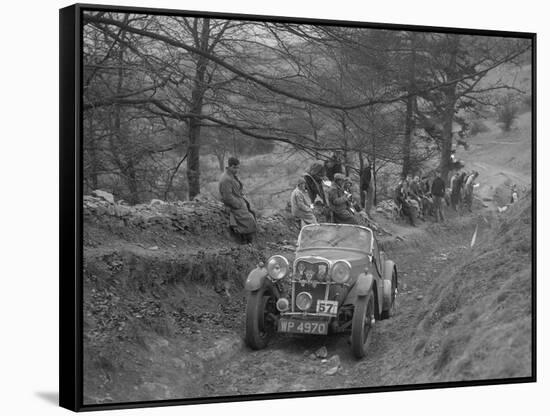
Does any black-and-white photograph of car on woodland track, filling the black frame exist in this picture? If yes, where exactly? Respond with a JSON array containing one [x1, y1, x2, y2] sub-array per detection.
[[61, 2, 536, 409]]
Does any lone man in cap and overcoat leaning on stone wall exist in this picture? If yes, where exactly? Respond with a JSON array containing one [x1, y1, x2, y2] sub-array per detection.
[[219, 157, 257, 244]]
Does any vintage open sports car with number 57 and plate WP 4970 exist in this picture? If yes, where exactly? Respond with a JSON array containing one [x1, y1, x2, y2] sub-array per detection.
[[245, 224, 397, 358]]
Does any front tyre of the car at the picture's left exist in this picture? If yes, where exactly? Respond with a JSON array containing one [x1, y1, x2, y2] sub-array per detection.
[[244, 287, 277, 350]]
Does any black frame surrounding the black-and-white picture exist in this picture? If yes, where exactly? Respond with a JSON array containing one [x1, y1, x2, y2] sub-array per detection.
[[59, 4, 537, 411]]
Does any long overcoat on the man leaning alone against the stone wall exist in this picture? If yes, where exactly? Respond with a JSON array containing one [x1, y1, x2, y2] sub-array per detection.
[[219, 170, 256, 234]]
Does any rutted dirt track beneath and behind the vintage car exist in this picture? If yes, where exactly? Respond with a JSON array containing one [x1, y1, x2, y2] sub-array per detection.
[[177, 218, 484, 395]]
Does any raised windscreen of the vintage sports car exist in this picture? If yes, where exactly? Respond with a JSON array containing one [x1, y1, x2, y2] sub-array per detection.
[[298, 224, 372, 252]]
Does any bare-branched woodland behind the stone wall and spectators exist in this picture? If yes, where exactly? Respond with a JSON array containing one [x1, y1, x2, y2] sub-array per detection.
[[83, 12, 532, 209]]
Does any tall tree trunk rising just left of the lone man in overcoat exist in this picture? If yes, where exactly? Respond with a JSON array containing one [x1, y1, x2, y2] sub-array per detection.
[[187, 19, 210, 199]]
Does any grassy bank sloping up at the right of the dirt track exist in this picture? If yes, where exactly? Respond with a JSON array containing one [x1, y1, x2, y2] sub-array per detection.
[[410, 194, 532, 381]]
